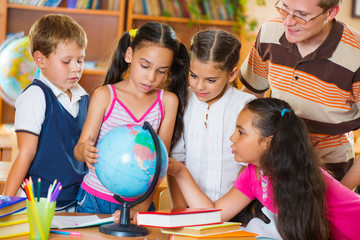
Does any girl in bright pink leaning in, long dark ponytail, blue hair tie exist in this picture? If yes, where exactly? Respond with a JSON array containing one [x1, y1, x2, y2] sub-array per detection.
[[168, 98, 360, 240]]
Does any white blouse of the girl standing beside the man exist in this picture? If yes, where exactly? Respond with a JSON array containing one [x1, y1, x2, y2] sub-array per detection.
[[171, 86, 255, 201]]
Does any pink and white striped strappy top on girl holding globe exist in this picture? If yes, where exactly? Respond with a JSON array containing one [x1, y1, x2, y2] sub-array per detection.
[[81, 85, 164, 203]]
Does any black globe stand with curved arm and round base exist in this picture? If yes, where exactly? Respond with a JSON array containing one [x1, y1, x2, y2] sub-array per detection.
[[99, 122, 161, 237]]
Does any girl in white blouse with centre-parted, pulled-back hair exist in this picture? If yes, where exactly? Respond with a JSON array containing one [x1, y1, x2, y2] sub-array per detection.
[[168, 29, 254, 218]]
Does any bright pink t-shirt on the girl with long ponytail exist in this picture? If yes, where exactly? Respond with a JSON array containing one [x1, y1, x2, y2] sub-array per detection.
[[234, 164, 360, 239]]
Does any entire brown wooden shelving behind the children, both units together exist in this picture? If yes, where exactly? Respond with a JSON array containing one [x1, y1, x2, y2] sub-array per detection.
[[0, 0, 245, 124]]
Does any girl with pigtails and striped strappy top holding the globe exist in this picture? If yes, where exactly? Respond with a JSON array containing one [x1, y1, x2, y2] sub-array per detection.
[[74, 23, 189, 215]]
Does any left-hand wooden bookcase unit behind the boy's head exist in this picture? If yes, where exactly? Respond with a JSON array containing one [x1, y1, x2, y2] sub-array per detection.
[[0, 0, 126, 123]]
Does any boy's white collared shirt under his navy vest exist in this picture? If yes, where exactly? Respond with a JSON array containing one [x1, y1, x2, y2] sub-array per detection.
[[15, 74, 87, 135]]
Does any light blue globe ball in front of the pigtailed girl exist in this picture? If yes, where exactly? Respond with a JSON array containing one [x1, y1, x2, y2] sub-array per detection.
[[94, 125, 168, 201]]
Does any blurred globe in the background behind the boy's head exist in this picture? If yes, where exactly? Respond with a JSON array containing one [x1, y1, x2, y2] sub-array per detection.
[[0, 32, 40, 106]]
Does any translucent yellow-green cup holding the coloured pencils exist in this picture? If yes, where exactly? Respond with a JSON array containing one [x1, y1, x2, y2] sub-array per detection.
[[26, 198, 56, 240]]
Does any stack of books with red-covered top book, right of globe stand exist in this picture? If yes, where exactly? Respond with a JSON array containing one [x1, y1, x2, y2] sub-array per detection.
[[137, 208, 257, 240]]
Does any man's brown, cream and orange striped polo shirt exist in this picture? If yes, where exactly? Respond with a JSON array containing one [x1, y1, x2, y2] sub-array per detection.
[[241, 18, 360, 163]]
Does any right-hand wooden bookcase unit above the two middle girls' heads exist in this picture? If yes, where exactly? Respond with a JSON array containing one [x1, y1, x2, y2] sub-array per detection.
[[126, 0, 240, 47]]
